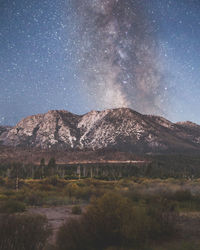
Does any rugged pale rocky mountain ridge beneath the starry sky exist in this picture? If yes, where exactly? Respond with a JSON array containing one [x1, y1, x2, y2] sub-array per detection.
[[0, 108, 200, 153]]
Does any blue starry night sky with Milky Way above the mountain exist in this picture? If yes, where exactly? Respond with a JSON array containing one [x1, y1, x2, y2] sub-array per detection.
[[0, 0, 200, 125]]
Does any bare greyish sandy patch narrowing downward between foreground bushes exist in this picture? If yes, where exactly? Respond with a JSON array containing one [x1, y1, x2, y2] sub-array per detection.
[[27, 205, 84, 243]]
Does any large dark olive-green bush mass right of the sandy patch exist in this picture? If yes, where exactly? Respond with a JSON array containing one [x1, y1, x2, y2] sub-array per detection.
[[57, 193, 174, 250]]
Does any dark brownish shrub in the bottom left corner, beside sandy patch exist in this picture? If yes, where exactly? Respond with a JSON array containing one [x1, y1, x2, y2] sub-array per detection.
[[0, 215, 50, 250]]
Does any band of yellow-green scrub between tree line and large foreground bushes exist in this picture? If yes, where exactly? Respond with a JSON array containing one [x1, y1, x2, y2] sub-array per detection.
[[0, 176, 200, 213]]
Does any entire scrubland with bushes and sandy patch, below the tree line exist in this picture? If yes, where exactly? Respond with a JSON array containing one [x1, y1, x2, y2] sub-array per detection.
[[0, 176, 200, 250]]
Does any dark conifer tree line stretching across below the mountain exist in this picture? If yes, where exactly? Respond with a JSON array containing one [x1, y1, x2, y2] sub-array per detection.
[[0, 155, 200, 184]]
